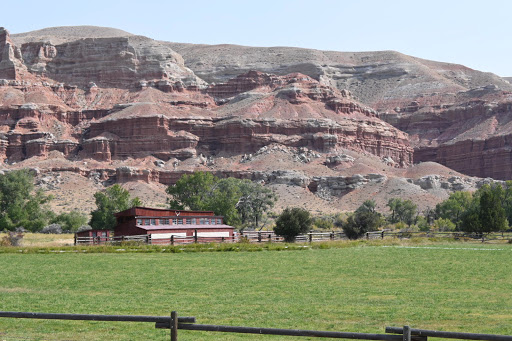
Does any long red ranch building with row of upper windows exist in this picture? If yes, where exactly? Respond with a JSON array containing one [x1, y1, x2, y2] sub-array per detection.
[[114, 207, 234, 244]]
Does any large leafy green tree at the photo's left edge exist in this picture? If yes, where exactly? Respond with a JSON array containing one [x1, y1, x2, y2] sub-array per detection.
[[0, 170, 54, 232]]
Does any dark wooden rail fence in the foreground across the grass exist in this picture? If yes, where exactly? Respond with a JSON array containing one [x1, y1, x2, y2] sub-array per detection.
[[0, 311, 512, 341]]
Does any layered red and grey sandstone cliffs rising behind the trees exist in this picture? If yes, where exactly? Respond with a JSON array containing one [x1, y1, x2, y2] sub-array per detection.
[[4, 27, 512, 212]]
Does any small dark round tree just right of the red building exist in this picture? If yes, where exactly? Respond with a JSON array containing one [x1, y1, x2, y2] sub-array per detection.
[[274, 207, 312, 242]]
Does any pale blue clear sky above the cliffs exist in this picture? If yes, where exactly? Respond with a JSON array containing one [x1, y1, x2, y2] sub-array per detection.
[[0, 0, 512, 77]]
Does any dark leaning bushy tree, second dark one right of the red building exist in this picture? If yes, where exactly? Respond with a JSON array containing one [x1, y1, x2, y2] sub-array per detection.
[[342, 200, 382, 239]]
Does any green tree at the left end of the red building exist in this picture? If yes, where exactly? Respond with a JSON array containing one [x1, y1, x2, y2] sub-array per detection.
[[90, 184, 142, 230]]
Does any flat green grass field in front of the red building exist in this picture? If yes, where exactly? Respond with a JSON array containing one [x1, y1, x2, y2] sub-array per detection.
[[0, 243, 512, 340]]
